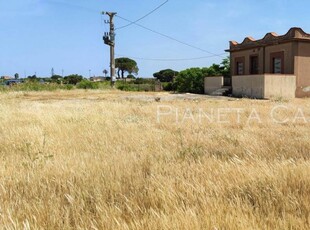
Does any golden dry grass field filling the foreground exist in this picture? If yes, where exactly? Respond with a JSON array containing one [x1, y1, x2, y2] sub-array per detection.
[[0, 90, 310, 230]]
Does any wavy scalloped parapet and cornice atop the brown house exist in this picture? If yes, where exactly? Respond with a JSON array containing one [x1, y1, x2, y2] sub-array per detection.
[[226, 27, 310, 51]]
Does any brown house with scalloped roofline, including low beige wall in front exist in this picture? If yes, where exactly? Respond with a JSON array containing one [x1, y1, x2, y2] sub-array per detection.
[[226, 28, 310, 98]]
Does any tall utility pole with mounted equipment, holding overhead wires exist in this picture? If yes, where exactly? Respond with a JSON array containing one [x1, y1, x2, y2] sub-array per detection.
[[102, 12, 116, 87]]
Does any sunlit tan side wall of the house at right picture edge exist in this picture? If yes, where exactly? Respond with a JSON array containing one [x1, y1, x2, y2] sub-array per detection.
[[295, 42, 310, 97]]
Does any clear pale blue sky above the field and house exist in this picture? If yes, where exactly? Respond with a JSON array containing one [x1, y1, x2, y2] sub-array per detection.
[[0, 0, 310, 77]]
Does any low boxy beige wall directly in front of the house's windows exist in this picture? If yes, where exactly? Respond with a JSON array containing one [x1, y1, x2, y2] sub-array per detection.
[[232, 74, 296, 99]]
